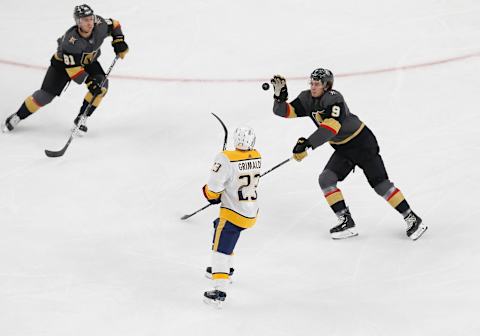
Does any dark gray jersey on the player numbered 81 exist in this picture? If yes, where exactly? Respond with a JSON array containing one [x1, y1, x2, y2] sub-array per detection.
[[54, 15, 122, 83]]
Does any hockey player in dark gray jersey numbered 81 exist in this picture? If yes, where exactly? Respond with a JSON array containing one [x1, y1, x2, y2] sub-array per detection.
[[2, 5, 128, 133]]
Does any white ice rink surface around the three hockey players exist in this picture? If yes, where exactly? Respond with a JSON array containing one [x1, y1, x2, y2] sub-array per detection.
[[0, 0, 480, 336]]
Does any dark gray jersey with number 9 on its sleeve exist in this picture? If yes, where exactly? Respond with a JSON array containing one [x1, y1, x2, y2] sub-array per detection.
[[273, 90, 365, 149]]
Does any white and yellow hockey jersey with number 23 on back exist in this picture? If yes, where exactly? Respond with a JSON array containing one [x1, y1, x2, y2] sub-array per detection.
[[206, 150, 262, 228]]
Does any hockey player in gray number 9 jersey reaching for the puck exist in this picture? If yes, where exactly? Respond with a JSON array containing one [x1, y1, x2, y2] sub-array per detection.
[[271, 68, 427, 240]]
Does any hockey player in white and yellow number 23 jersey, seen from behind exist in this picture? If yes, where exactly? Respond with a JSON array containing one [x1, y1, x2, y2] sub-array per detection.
[[203, 127, 262, 308]]
